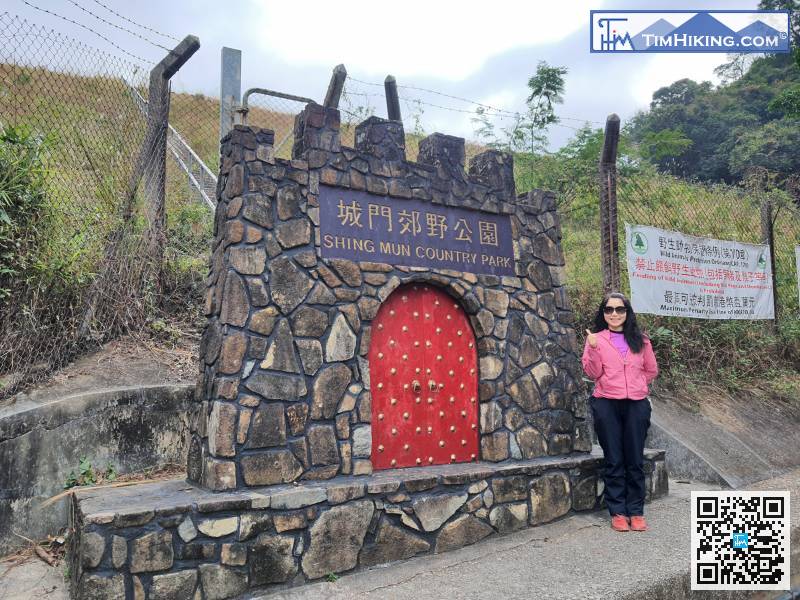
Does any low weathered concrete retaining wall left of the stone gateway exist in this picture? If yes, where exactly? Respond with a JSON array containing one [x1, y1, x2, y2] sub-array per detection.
[[0, 384, 199, 556]]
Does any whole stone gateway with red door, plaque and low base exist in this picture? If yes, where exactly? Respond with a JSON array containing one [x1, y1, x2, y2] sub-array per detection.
[[71, 91, 667, 598]]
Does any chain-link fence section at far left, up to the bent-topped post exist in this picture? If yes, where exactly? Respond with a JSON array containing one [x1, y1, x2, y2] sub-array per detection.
[[0, 13, 146, 393]]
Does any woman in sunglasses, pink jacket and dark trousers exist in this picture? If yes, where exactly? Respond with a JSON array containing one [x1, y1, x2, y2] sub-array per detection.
[[582, 292, 658, 531]]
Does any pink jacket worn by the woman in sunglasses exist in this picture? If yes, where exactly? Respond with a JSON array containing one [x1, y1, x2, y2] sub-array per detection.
[[581, 329, 658, 400]]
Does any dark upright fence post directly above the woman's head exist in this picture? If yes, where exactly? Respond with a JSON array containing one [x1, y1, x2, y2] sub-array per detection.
[[600, 114, 620, 294]]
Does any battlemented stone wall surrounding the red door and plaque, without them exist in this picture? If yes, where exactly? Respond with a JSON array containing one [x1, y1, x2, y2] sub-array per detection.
[[188, 104, 591, 490]]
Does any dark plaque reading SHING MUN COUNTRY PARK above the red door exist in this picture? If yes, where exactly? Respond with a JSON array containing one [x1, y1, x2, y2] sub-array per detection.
[[319, 185, 515, 275]]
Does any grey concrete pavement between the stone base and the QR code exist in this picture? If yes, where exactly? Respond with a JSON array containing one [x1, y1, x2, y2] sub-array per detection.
[[250, 481, 706, 600]]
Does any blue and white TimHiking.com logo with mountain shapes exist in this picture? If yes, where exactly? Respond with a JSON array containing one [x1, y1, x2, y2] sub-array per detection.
[[589, 10, 791, 53]]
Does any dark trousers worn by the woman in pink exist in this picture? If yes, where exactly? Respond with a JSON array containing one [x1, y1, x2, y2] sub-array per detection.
[[590, 397, 650, 516]]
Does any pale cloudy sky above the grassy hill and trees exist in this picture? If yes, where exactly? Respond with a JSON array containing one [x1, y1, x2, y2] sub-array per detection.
[[9, 0, 757, 149]]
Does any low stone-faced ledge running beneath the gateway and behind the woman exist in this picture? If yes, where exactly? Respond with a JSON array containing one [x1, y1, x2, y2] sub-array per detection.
[[70, 448, 668, 599]]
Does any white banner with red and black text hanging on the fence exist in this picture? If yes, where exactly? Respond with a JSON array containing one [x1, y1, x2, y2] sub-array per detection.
[[625, 223, 776, 319]]
